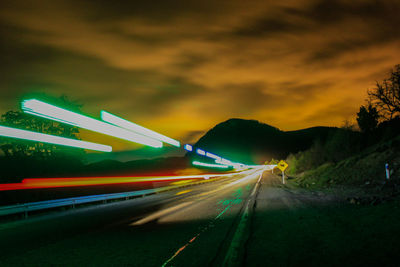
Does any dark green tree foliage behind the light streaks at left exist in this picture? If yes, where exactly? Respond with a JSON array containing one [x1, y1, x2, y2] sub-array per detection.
[[0, 96, 85, 182]]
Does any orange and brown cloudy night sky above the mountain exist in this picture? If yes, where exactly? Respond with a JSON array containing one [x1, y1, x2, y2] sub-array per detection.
[[0, 0, 400, 156]]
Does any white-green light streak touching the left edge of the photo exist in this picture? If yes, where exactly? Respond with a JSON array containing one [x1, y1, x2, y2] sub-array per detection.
[[0, 126, 112, 152]]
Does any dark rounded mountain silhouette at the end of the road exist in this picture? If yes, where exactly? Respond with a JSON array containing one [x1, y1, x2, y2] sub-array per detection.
[[189, 119, 340, 164]]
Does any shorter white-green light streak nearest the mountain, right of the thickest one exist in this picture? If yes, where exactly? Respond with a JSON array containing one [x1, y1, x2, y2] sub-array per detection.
[[100, 110, 181, 147]]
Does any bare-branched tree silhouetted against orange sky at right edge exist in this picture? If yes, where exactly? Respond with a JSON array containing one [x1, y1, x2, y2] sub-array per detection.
[[368, 64, 400, 119]]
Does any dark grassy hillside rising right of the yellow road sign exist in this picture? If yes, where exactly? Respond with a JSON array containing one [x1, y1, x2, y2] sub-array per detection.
[[287, 118, 400, 191]]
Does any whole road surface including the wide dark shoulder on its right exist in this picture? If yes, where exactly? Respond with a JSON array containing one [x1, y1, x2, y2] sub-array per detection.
[[0, 170, 400, 266]]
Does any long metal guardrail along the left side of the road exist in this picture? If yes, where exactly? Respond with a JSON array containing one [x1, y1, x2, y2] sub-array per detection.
[[0, 189, 160, 217]]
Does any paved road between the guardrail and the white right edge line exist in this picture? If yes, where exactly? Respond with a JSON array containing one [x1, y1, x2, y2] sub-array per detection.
[[0, 169, 263, 266]]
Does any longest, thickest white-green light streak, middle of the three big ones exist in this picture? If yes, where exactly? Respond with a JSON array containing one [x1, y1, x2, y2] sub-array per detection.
[[22, 99, 162, 148]]
